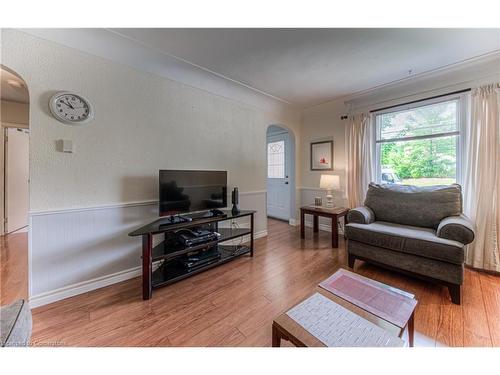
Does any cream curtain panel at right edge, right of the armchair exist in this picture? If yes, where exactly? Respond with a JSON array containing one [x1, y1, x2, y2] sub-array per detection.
[[464, 84, 500, 272]]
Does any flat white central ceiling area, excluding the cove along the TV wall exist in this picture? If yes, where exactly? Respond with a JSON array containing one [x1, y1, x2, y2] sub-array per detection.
[[111, 29, 500, 107]]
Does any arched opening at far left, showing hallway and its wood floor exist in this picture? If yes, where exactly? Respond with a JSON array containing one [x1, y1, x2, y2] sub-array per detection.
[[0, 65, 29, 305]]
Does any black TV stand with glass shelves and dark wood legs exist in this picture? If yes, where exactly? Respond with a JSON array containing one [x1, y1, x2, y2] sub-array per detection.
[[129, 210, 256, 300]]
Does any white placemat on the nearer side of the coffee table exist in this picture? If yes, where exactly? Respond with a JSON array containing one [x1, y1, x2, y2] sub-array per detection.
[[286, 293, 404, 347]]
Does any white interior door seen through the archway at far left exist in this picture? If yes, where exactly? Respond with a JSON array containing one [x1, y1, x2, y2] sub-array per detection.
[[5, 128, 29, 233]]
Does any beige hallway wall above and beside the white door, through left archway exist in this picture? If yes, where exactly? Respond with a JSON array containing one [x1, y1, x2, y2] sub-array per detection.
[[0, 100, 29, 235]]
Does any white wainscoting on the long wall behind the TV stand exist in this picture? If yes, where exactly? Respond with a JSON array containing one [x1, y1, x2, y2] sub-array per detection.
[[30, 190, 267, 307]]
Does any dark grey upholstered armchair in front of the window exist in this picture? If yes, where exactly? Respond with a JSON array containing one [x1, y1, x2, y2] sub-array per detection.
[[346, 183, 474, 304]]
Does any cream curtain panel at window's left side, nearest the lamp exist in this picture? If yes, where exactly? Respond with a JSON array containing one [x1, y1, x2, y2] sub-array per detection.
[[345, 113, 375, 208]]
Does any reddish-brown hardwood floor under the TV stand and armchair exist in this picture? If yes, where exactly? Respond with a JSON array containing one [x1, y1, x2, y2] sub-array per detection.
[[2, 220, 500, 346]]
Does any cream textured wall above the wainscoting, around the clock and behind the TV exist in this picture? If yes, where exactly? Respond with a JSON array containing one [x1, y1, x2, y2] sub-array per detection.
[[2, 30, 300, 211]]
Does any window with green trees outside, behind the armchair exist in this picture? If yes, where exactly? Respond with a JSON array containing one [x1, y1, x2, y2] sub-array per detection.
[[375, 96, 465, 186]]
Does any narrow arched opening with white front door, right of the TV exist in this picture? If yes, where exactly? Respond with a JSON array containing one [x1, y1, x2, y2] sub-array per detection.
[[266, 125, 296, 224]]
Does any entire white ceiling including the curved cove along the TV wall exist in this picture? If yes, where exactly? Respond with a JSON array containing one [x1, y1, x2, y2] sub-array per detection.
[[17, 28, 500, 108]]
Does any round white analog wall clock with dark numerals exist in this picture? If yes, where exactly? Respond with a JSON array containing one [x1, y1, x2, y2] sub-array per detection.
[[49, 91, 94, 125]]
